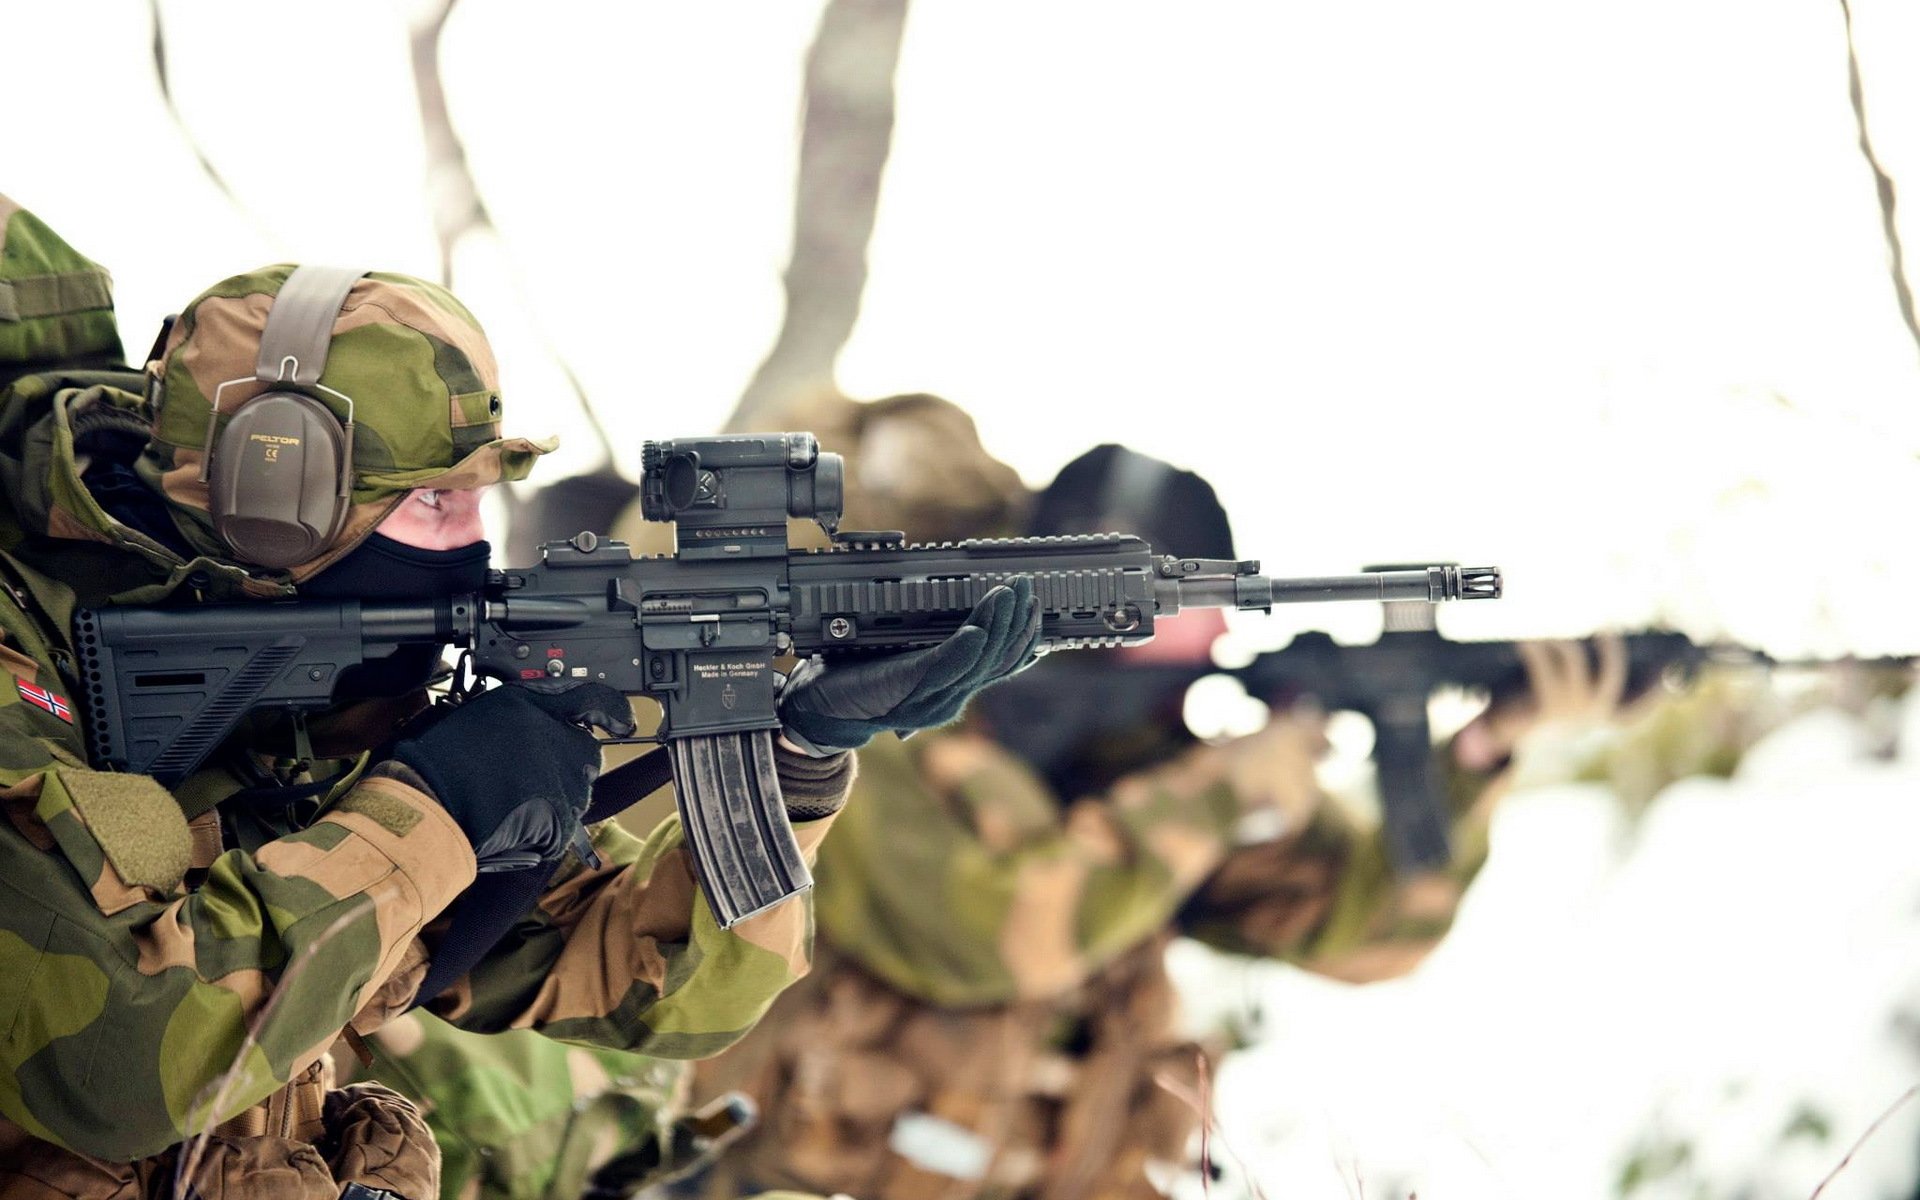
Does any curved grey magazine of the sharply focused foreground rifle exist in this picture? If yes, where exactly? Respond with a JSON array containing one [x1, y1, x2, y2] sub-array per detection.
[[666, 730, 814, 929]]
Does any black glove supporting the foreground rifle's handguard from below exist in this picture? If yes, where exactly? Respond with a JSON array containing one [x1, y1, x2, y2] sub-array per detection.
[[780, 576, 1041, 756]]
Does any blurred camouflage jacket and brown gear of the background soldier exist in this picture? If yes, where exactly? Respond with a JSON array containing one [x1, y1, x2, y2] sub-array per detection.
[[695, 732, 1482, 1200]]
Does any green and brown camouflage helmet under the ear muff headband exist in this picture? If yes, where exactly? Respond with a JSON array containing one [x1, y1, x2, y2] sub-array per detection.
[[140, 263, 555, 582]]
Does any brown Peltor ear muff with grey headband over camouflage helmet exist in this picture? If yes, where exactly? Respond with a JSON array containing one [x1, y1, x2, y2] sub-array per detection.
[[200, 267, 367, 568]]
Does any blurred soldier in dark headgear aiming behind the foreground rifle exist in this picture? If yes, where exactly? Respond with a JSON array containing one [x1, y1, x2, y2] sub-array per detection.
[[695, 438, 1473, 1200]]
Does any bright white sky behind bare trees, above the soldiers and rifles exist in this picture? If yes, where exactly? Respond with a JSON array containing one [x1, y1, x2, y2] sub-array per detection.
[[11, 0, 1920, 653]]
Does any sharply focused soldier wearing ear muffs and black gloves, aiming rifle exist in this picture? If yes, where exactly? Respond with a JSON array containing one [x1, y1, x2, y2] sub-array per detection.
[[0, 200, 1039, 1200]]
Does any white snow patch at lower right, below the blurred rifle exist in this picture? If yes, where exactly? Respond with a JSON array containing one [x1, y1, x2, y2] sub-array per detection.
[[1171, 703, 1920, 1200]]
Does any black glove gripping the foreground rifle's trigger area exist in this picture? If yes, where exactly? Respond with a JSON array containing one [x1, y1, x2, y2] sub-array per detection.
[[386, 684, 634, 870]]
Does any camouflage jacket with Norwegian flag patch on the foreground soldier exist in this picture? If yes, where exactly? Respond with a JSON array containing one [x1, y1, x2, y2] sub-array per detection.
[[0, 372, 851, 1194]]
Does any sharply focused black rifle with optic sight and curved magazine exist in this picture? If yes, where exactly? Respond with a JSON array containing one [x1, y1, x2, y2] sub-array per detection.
[[75, 434, 1500, 927]]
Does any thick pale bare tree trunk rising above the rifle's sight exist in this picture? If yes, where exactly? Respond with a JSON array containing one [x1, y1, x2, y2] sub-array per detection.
[[726, 0, 906, 432]]
